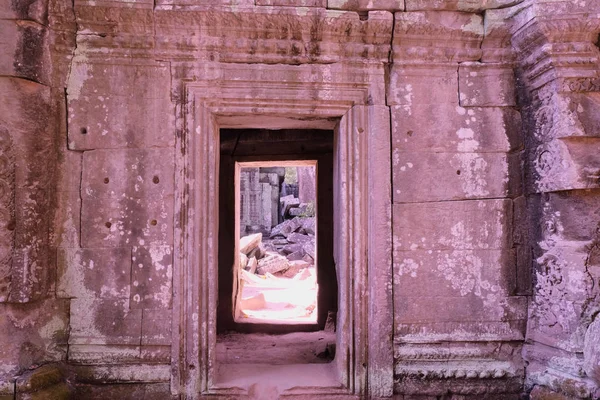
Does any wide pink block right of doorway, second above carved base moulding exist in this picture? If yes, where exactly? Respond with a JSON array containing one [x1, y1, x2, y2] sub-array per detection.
[[392, 199, 512, 250]]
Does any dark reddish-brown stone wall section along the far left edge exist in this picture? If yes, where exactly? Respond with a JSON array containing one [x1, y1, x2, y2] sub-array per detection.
[[0, 1, 72, 398]]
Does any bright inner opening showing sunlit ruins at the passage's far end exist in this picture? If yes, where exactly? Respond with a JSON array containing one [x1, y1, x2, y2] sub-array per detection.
[[233, 160, 318, 324]]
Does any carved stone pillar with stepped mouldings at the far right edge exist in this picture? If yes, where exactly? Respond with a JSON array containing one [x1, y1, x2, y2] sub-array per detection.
[[513, 1, 600, 399]]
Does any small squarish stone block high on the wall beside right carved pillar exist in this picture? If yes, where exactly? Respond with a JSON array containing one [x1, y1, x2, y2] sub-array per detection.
[[458, 62, 517, 107]]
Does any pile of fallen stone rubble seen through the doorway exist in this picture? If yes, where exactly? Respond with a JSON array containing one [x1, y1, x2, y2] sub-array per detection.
[[239, 217, 315, 278]]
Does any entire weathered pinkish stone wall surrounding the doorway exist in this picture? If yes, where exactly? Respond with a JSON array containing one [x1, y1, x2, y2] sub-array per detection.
[[0, 0, 600, 400]]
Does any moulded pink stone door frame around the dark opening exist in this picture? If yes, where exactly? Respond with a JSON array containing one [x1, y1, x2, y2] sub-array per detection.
[[171, 64, 393, 399]]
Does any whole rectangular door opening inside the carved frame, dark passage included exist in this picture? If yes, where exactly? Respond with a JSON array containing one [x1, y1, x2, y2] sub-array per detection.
[[216, 129, 338, 378]]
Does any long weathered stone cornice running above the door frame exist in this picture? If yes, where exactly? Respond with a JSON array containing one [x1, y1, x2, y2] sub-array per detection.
[[71, 6, 393, 64]]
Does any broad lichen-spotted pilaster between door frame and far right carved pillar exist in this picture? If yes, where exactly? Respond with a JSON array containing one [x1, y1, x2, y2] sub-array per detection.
[[388, 11, 527, 399]]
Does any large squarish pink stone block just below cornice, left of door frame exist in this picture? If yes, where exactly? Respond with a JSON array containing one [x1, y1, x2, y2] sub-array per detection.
[[67, 61, 175, 150]]
